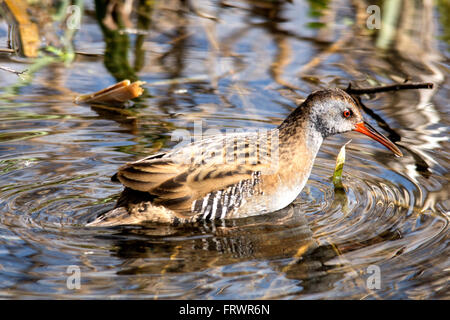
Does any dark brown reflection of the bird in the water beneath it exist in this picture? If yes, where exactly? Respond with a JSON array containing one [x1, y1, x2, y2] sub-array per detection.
[[90, 204, 340, 291]]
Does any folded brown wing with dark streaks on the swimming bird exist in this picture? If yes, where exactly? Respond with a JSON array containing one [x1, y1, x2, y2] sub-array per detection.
[[117, 130, 278, 216]]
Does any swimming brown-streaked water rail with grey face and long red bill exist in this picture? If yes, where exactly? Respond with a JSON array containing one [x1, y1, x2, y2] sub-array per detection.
[[88, 89, 401, 226]]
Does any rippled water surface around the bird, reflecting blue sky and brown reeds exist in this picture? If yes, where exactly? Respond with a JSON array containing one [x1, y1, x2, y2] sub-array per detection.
[[0, 0, 450, 299]]
